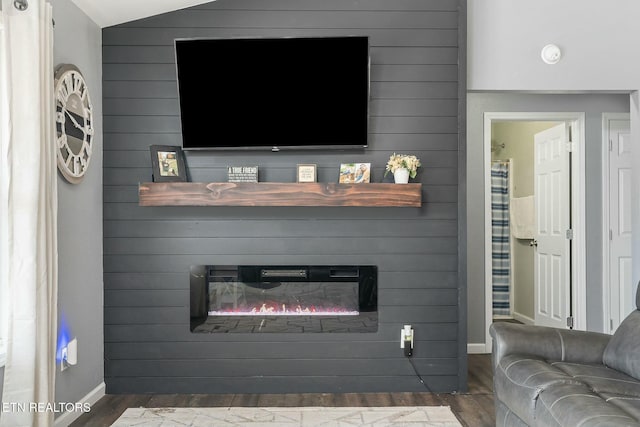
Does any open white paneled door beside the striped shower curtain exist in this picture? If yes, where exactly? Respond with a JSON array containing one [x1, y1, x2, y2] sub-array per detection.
[[534, 123, 571, 328]]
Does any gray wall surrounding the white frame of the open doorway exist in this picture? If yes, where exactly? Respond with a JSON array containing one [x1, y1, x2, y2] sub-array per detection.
[[467, 93, 629, 344]]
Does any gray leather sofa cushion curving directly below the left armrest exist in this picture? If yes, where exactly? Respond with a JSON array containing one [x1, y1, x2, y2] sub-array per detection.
[[494, 354, 581, 425]]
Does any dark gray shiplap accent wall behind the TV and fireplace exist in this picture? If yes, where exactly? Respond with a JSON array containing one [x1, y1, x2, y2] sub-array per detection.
[[103, 0, 466, 393]]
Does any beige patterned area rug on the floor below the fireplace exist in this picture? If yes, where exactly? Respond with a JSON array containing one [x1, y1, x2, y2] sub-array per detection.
[[112, 406, 461, 427]]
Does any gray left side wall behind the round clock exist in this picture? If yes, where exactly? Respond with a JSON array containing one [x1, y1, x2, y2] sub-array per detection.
[[53, 0, 104, 408]]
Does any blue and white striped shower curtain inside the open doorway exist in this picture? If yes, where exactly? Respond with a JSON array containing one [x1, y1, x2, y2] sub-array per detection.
[[491, 162, 511, 316]]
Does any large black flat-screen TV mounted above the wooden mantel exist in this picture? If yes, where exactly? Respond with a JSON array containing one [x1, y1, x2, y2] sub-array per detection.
[[175, 37, 369, 150]]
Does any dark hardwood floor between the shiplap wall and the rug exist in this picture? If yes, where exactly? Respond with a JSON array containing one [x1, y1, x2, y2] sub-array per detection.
[[71, 354, 495, 427]]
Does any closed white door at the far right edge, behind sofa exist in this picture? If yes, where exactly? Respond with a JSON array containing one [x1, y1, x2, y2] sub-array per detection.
[[609, 120, 635, 333]]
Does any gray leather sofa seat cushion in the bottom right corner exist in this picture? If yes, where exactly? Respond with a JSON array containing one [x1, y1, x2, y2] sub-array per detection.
[[530, 384, 640, 427]]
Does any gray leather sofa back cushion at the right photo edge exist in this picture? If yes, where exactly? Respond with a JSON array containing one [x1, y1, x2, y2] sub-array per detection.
[[603, 310, 640, 379]]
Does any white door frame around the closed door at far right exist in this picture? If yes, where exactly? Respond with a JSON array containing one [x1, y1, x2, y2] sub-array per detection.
[[602, 113, 633, 333]]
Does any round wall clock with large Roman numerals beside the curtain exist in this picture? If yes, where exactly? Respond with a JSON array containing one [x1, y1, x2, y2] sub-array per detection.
[[55, 64, 93, 184]]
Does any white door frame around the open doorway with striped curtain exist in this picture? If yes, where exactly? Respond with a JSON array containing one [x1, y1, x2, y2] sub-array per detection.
[[483, 112, 587, 353]]
